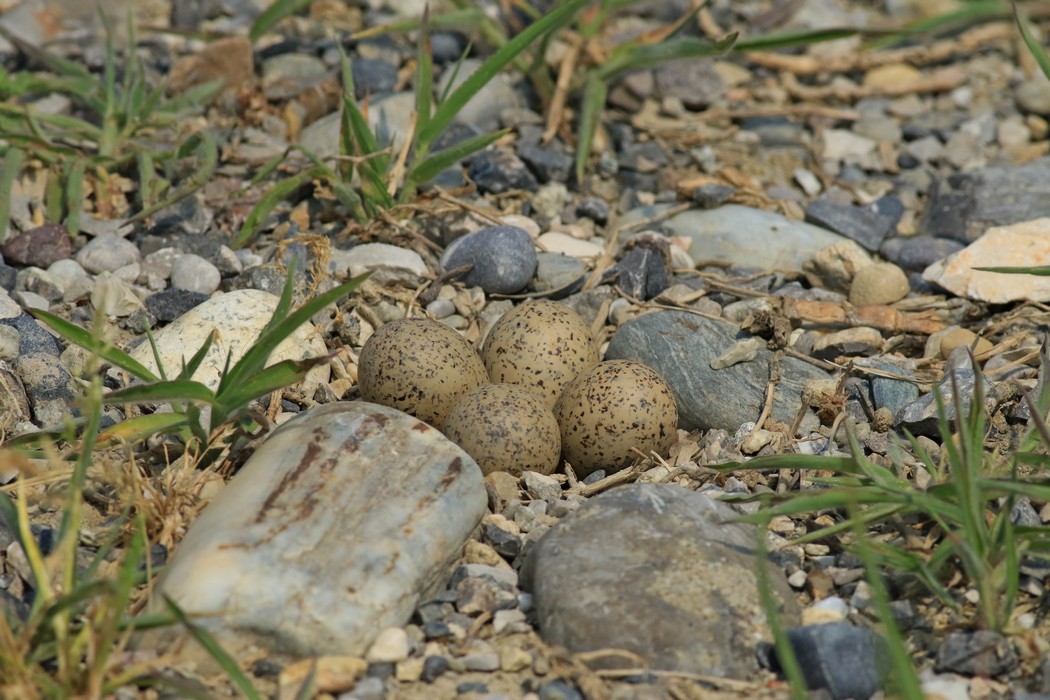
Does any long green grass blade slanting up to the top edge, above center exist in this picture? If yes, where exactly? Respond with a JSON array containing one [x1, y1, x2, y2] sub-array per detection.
[[416, 0, 590, 153]]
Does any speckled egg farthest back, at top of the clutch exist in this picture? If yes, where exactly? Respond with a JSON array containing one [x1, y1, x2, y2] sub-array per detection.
[[481, 299, 599, 406]]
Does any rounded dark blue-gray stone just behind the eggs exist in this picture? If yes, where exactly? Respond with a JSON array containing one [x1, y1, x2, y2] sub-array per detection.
[[441, 226, 538, 294]]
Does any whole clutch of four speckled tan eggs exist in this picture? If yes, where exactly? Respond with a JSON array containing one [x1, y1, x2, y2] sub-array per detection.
[[358, 300, 678, 479]]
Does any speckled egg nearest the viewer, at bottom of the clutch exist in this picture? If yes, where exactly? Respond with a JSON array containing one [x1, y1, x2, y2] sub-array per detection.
[[444, 384, 562, 476]]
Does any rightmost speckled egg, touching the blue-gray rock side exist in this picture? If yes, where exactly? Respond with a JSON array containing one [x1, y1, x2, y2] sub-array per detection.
[[554, 360, 678, 479]]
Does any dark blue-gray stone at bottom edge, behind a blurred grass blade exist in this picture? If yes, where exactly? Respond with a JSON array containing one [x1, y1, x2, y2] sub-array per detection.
[[774, 622, 889, 700]]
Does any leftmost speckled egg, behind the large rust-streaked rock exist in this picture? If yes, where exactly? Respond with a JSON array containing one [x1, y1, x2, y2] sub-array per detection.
[[357, 318, 488, 428]]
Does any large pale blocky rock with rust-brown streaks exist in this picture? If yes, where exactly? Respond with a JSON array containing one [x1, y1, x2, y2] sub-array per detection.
[[137, 402, 487, 662]]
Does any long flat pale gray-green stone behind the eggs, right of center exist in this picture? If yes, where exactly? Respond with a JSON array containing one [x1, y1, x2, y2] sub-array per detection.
[[663, 205, 844, 270]]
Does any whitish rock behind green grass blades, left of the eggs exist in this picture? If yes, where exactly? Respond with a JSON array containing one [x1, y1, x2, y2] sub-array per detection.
[[131, 290, 330, 388]]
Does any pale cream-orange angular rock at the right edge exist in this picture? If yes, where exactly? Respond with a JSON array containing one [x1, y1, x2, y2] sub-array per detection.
[[922, 219, 1050, 303]]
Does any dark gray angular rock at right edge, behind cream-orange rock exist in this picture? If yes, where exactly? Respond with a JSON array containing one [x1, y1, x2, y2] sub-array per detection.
[[919, 157, 1050, 243]]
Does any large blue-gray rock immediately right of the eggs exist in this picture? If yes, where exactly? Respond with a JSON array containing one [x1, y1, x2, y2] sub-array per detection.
[[606, 311, 828, 431]]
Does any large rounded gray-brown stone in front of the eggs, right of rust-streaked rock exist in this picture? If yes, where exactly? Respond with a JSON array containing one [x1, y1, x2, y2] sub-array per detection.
[[522, 484, 800, 678]]
